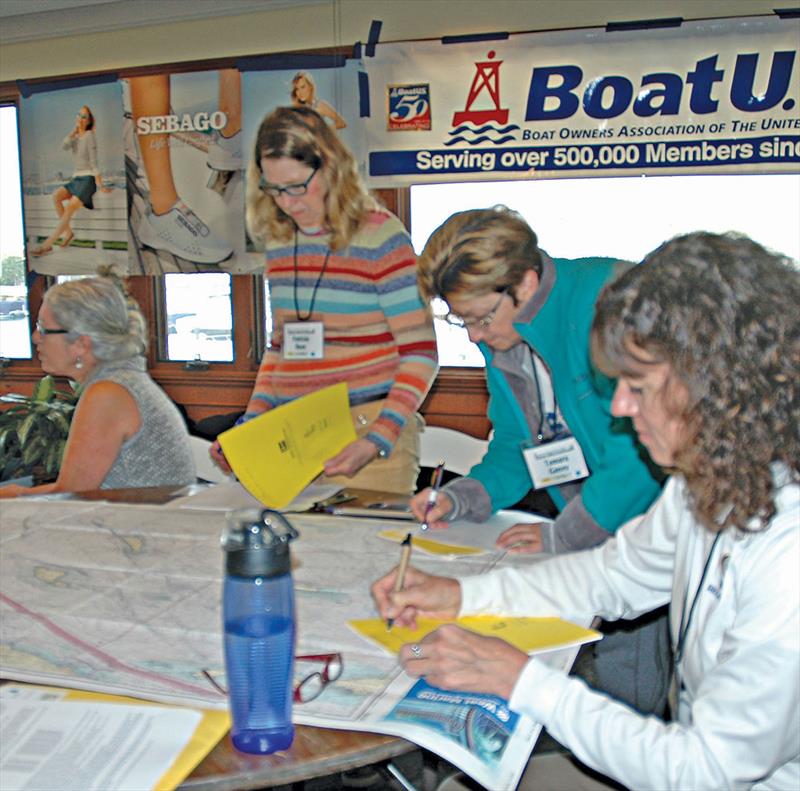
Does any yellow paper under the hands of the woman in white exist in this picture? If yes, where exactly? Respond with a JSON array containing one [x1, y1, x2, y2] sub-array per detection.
[[349, 616, 602, 654]]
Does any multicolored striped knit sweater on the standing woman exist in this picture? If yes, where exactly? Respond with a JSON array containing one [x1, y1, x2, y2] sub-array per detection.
[[245, 211, 437, 455]]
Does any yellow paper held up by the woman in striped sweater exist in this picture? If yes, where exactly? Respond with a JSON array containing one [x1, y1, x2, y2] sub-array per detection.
[[219, 382, 356, 508]]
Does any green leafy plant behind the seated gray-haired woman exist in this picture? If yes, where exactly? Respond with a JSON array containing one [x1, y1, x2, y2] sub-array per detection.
[[0, 375, 80, 483]]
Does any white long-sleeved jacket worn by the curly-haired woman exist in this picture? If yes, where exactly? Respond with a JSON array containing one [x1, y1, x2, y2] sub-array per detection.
[[461, 475, 800, 791]]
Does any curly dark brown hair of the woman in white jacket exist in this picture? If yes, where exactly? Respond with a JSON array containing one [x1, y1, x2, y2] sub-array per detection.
[[592, 232, 800, 530]]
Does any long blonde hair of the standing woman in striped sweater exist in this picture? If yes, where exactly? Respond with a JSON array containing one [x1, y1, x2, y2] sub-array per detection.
[[246, 107, 378, 250]]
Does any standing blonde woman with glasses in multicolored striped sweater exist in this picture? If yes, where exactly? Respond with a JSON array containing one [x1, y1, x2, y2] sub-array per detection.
[[212, 107, 437, 494]]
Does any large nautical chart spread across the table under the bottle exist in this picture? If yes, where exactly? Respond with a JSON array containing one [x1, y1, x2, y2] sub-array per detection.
[[0, 499, 576, 788]]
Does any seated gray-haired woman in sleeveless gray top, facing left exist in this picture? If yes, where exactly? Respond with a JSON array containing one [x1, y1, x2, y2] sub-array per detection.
[[0, 277, 196, 498]]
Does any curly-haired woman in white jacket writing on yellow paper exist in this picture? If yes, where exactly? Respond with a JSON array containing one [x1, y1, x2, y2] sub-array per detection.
[[372, 233, 800, 789]]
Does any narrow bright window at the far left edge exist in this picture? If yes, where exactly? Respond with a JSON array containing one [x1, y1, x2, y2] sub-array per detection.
[[0, 105, 31, 359]]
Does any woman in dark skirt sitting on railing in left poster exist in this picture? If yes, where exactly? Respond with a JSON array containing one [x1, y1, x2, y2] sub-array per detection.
[[31, 105, 111, 256]]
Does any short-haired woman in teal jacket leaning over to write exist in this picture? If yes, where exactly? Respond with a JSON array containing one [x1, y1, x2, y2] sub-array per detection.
[[412, 207, 660, 552]]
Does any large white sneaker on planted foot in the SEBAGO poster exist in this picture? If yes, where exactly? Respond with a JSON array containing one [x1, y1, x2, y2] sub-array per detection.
[[138, 201, 233, 264]]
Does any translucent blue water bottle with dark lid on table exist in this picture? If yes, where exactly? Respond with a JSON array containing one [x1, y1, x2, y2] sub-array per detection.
[[222, 509, 298, 754]]
